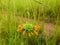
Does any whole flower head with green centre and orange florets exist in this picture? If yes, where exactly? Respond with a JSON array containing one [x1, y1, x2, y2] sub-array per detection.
[[17, 23, 40, 37]]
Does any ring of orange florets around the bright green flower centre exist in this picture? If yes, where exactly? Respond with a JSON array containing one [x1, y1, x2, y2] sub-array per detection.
[[17, 22, 40, 37]]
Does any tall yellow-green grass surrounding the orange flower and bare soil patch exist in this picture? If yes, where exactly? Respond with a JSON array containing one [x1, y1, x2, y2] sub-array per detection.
[[0, 0, 60, 45]]
